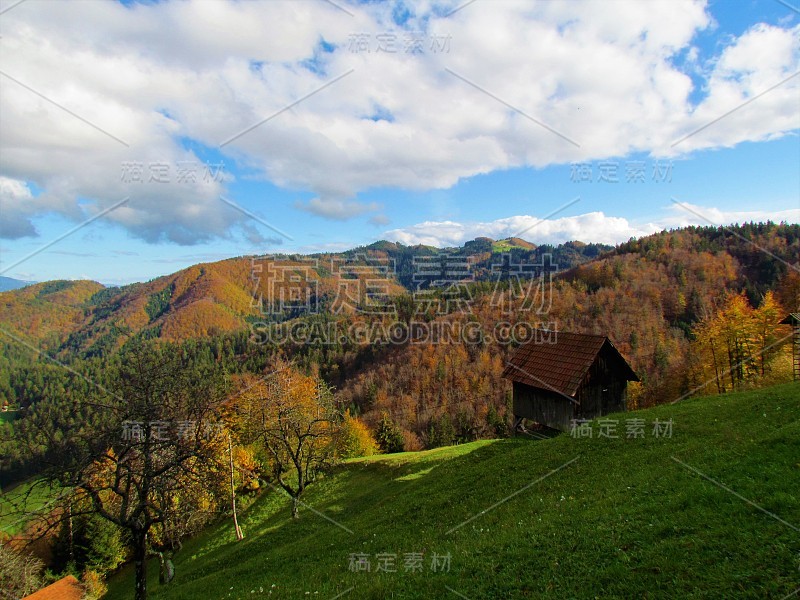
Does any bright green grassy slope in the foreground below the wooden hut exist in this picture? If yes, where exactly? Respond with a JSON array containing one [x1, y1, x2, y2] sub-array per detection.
[[107, 384, 800, 600]]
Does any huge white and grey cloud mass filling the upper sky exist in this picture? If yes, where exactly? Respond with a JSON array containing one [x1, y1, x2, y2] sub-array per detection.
[[0, 0, 800, 244]]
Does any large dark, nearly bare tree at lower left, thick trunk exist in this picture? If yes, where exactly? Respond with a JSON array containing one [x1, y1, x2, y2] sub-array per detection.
[[18, 343, 226, 600]]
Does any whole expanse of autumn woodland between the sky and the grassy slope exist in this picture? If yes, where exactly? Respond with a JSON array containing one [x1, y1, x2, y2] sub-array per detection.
[[0, 224, 800, 593]]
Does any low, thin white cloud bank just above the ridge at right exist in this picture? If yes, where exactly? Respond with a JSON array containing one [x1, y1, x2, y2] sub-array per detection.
[[383, 203, 800, 248]]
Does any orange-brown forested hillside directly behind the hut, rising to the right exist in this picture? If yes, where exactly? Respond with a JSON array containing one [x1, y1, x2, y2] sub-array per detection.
[[340, 225, 800, 449]]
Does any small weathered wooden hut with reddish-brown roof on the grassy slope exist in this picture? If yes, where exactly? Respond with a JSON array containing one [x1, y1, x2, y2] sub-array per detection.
[[503, 331, 639, 431]]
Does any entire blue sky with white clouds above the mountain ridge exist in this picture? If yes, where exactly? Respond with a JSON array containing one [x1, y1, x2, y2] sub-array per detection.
[[0, 0, 800, 284]]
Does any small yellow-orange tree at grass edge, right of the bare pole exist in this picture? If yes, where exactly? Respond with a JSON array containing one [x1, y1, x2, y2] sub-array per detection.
[[236, 363, 339, 518]]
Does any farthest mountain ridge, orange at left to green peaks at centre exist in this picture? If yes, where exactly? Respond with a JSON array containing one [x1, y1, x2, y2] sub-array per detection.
[[0, 238, 613, 355]]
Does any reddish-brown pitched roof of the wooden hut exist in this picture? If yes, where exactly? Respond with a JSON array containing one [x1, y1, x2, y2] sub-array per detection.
[[503, 331, 639, 397]]
